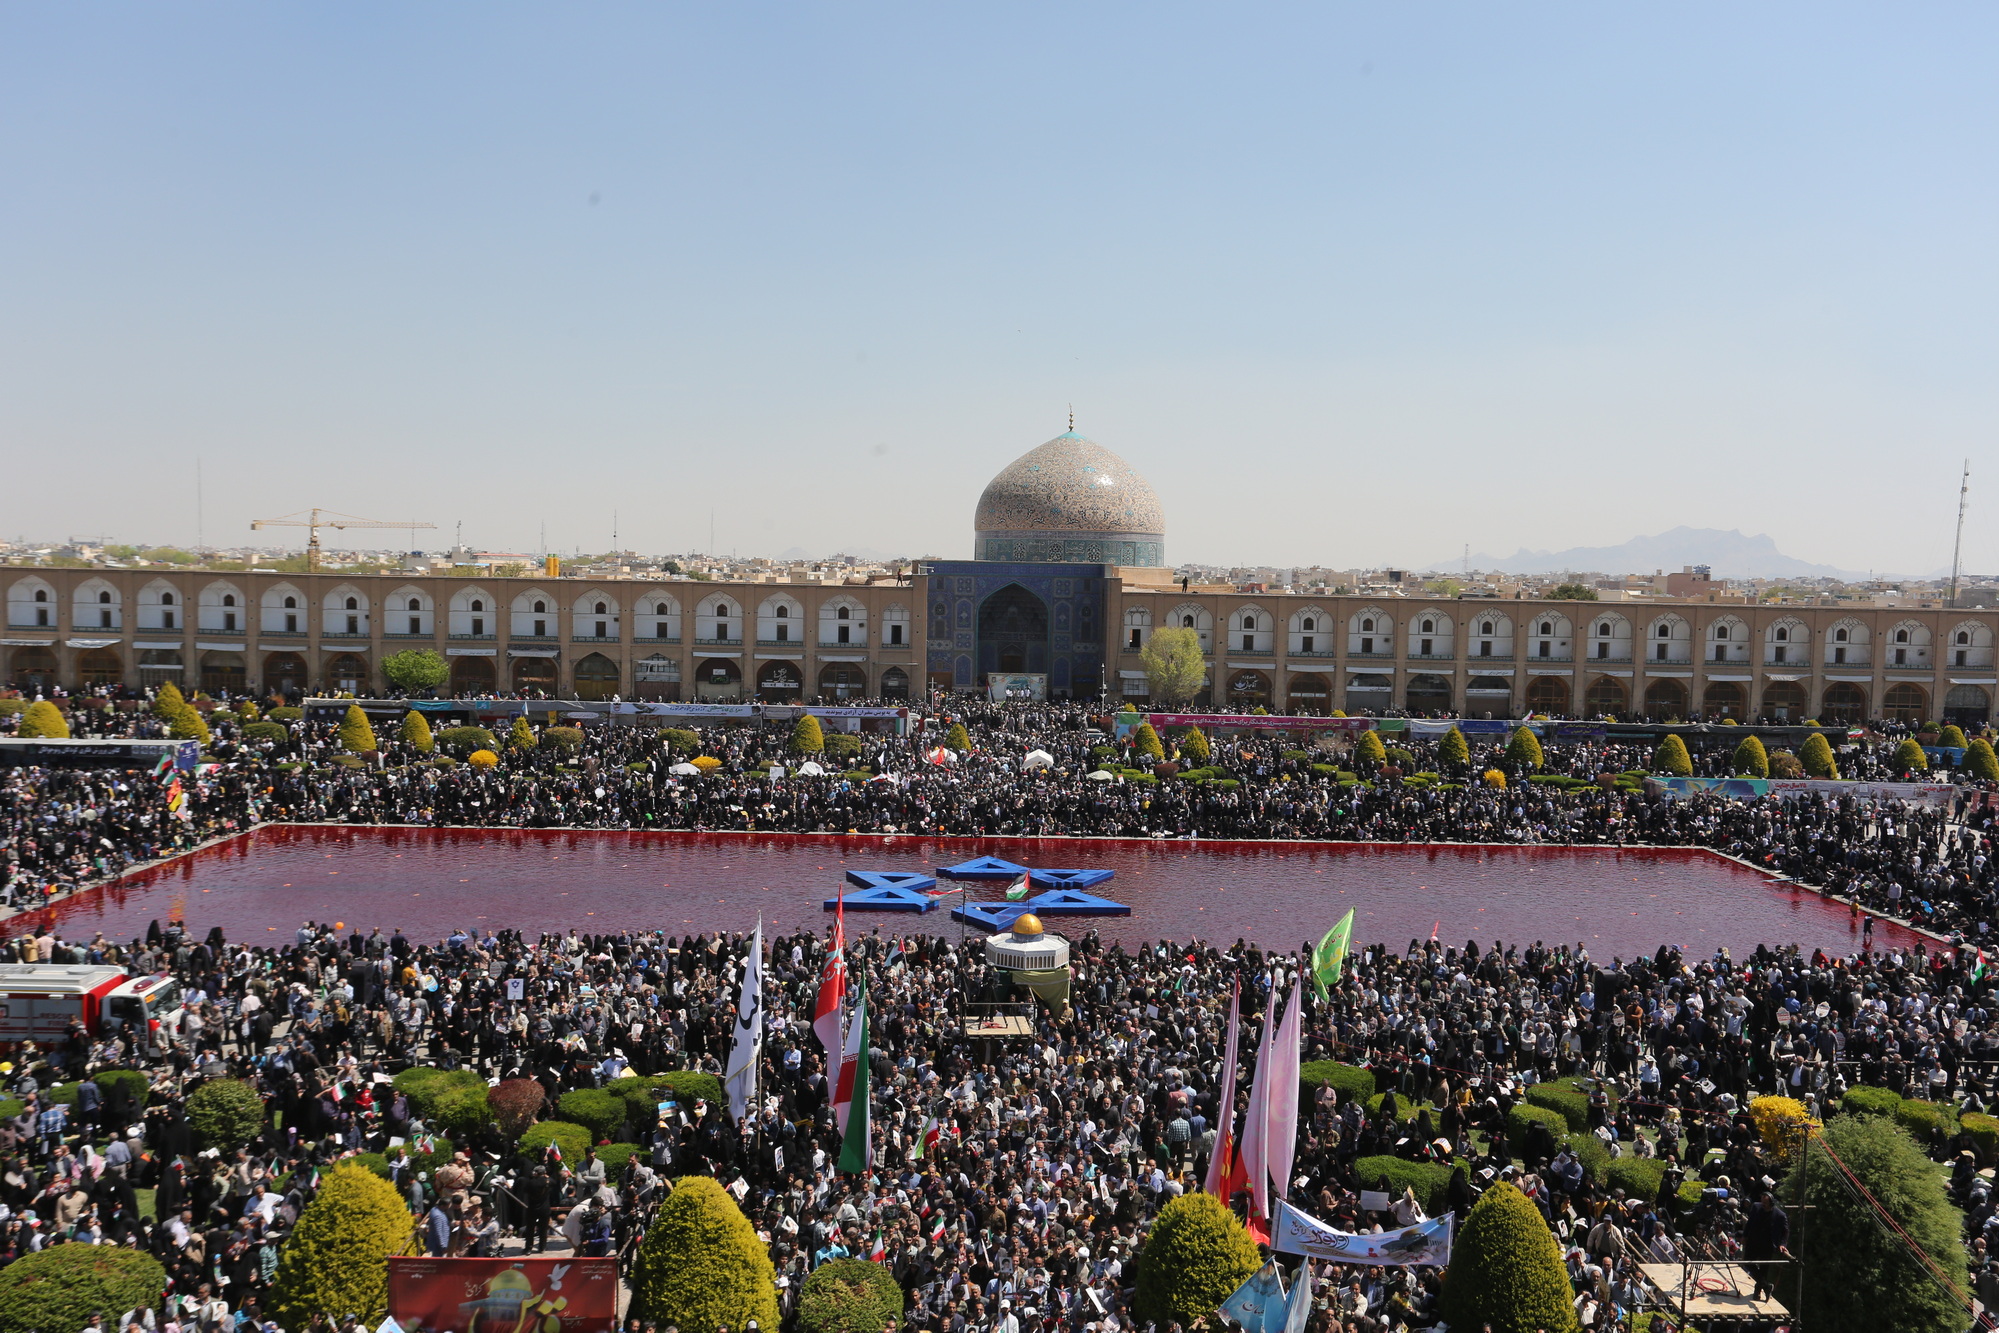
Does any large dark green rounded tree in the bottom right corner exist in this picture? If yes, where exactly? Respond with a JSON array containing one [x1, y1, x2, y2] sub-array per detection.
[[1779, 1115, 1969, 1333]]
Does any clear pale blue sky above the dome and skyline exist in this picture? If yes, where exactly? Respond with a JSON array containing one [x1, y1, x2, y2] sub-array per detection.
[[0, 2, 1999, 570]]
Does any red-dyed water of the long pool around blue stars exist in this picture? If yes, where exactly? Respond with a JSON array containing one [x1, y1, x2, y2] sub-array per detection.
[[11, 825, 1915, 957]]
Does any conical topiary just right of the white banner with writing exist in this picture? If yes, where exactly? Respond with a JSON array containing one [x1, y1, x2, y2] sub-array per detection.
[[1443, 1181, 1577, 1333]]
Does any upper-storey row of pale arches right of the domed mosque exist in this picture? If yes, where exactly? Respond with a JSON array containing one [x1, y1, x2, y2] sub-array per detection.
[[1123, 602, 1993, 669]]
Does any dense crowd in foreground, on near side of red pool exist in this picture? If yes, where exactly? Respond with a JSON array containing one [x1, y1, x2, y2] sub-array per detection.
[[0, 923, 1999, 1333]]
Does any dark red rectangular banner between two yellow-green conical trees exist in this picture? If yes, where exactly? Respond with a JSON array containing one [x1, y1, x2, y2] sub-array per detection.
[[388, 1259, 618, 1333]]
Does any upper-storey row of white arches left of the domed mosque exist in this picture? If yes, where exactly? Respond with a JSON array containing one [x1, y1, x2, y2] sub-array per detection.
[[8, 578, 912, 648]]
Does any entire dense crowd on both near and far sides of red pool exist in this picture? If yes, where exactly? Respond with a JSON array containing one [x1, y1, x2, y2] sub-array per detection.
[[0, 687, 1999, 1333]]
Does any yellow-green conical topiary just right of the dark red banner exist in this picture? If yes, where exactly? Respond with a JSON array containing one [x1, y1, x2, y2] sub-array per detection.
[[630, 1175, 778, 1333]]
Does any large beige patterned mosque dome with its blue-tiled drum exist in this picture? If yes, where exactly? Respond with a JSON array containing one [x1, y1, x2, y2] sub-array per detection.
[[974, 430, 1165, 566]]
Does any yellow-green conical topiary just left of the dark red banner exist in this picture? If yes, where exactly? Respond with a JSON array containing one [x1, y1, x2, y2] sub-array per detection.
[[270, 1161, 416, 1329]]
